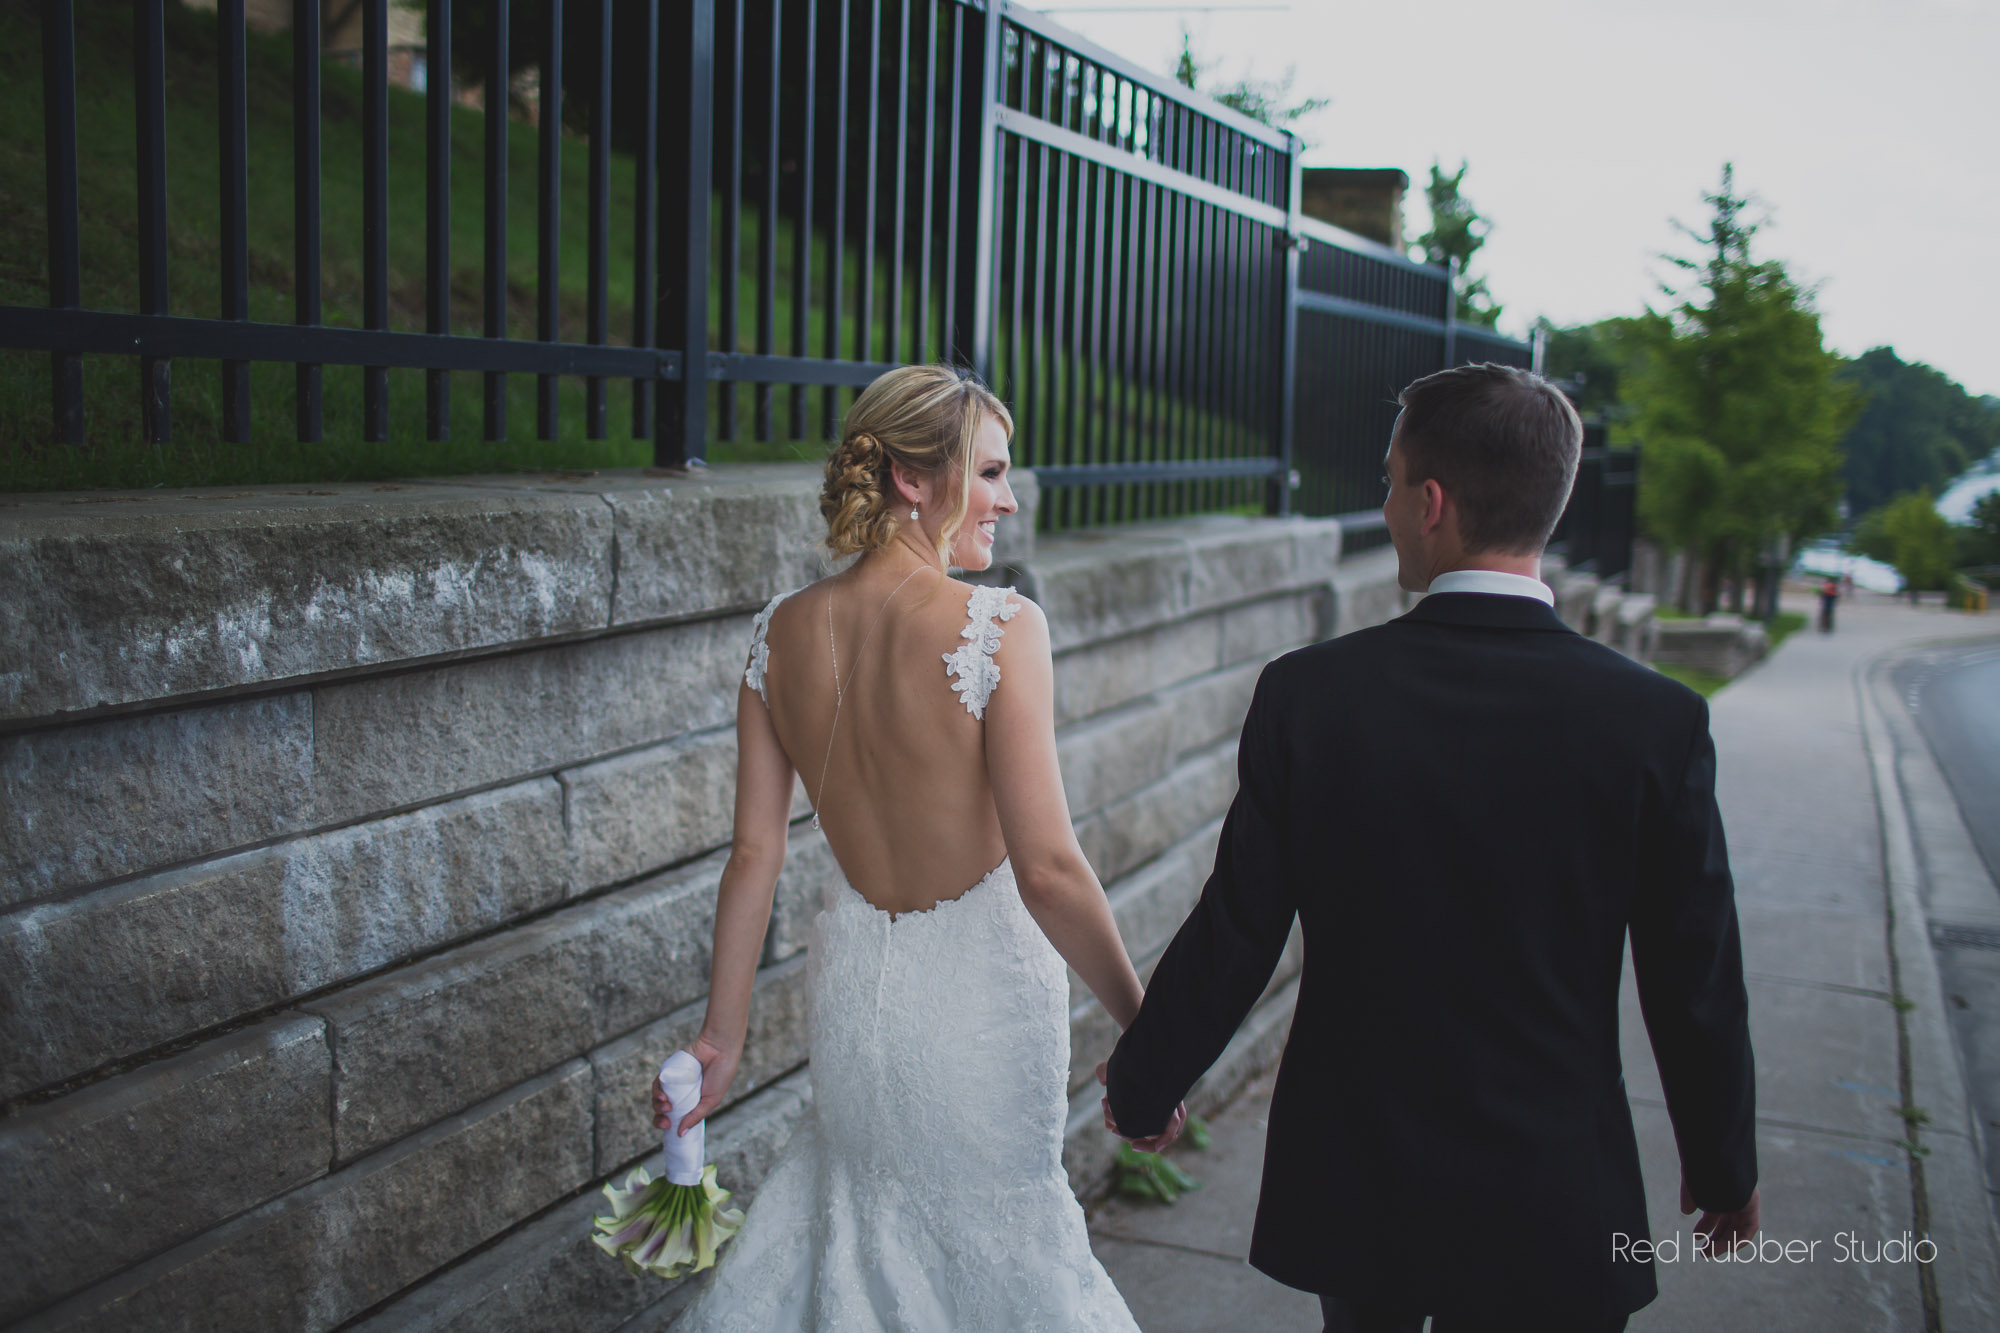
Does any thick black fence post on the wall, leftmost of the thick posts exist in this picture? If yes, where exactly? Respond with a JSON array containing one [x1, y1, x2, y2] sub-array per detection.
[[652, 0, 716, 470]]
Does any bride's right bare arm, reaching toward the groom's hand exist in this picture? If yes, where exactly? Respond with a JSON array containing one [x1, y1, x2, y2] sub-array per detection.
[[986, 598, 1144, 1029]]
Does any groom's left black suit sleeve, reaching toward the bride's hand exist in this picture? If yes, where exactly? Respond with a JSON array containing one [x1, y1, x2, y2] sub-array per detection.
[[1108, 664, 1296, 1139]]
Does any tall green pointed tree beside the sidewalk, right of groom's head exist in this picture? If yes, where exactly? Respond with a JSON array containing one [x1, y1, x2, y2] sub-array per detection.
[[1620, 164, 1854, 610]]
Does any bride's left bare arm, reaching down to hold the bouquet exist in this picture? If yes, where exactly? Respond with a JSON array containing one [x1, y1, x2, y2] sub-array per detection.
[[654, 685, 792, 1133]]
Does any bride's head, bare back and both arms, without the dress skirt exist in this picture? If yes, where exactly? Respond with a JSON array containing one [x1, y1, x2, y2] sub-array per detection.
[[654, 366, 1142, 1129]]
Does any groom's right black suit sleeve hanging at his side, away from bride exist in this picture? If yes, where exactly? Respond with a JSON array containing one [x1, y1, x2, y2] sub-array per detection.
[[1632, 705, 1756, 1211]]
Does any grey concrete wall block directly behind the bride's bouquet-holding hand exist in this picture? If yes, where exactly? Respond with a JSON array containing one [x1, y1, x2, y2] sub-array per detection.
[[590, 955, 808, 1168]]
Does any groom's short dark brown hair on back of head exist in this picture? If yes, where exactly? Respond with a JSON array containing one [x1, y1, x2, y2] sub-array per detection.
[[1396, 362, 1584, 554]]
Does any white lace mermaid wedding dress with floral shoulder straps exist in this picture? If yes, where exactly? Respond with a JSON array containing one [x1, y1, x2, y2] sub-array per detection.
[[674, 588, 1138, 1333]]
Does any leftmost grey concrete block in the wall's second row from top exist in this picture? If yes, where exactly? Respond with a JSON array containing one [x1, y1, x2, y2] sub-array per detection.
[[0, 693, 314, 909]]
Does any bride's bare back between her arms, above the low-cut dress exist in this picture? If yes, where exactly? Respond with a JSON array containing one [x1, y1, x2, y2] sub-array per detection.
[[746, 560, 1022, 915]]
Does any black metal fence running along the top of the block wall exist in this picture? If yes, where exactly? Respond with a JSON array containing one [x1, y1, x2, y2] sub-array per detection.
[[0, 0, 1604, 560]]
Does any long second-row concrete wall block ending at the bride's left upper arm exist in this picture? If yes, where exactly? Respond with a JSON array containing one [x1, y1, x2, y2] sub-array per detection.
[[310, 614, 750, 823]]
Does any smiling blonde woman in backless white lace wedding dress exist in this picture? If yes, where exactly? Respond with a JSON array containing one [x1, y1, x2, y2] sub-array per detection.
[[654, 366, 1182, 1333]]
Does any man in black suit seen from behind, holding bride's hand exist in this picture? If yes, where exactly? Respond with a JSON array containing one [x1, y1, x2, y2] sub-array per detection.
[[1106, 364, 1758, 1333]]
